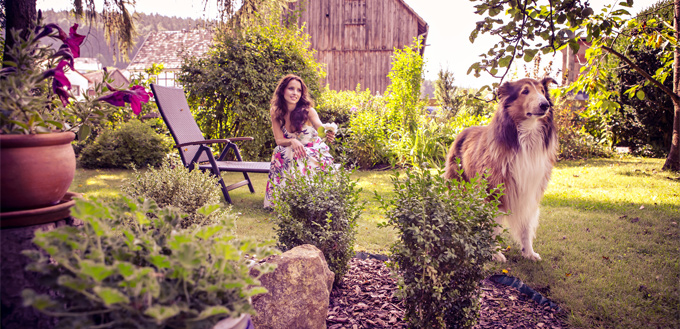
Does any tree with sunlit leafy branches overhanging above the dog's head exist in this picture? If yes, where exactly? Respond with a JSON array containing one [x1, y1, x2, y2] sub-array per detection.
[[468, 0, 680, 170]]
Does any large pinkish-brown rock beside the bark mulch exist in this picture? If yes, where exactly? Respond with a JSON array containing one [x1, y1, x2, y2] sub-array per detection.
[[251, 244, 333, 329]]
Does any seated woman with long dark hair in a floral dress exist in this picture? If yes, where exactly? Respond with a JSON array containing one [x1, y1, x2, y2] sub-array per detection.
[[264, 74, 335, 208]]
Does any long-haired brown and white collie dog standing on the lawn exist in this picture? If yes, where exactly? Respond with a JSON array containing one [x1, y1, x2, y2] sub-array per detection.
[[444, 78, 557, 261]]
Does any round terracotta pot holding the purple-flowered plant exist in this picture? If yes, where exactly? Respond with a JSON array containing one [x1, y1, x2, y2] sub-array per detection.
[[0, 132, 76, 212]]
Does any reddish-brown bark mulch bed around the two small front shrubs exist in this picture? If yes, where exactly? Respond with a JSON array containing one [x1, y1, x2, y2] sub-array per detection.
[[326, 258, 567, 329]]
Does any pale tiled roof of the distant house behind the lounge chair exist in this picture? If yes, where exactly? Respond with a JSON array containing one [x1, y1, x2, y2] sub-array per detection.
[[127, 30, 213, 71]]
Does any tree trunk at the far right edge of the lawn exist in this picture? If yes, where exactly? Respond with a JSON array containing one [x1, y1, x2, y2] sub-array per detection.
[[663, 0, 680, 171]]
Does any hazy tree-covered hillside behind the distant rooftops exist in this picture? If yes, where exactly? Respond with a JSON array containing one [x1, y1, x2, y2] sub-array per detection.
[[43, 10, 209, 69]]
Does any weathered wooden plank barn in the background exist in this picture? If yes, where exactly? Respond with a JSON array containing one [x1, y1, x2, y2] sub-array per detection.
[[291, 0, 428, 94]]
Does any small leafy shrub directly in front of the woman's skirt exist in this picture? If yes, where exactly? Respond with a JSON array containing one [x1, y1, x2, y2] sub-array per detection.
[[274, 162, 365, 285]]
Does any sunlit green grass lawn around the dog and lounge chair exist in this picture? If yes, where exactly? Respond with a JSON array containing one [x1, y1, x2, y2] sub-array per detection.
[[71, 158, 680, 328]]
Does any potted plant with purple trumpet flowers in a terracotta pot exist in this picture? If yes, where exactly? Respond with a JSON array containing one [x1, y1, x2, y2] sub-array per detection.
[[0, 14, 149, 212]]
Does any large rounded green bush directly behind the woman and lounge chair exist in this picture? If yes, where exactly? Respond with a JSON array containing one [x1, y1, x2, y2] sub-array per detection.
[[179, 17, 325, 159]]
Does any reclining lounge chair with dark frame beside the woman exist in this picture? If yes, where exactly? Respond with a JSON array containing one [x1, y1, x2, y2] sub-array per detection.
[[151, 84, 270, 203]]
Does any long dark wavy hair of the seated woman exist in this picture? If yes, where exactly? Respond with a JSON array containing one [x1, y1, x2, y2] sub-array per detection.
[[271, 74, 314, 132]]
